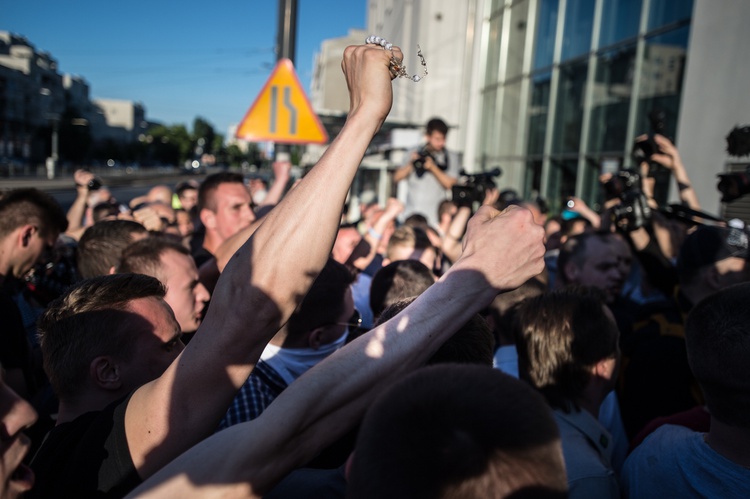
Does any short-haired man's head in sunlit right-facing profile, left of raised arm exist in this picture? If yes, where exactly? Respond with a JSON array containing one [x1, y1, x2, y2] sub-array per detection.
[[117, 236, 211, 334]]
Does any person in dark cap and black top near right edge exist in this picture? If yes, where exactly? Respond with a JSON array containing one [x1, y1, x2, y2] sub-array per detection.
[[620, 226, 750, 438]]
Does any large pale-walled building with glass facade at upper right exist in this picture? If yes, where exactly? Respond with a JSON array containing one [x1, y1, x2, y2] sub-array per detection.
[[367, 0, 750, 219]]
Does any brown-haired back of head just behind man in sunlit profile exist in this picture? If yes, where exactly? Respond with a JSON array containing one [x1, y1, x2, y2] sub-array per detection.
[[77, 220, 148, 279]]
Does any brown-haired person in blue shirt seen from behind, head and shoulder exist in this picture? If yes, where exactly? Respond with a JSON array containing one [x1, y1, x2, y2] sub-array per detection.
[[517, 289, 620, 498]]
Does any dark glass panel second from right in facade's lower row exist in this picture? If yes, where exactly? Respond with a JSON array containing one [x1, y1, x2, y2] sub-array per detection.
[[589, 45, 636, 152]]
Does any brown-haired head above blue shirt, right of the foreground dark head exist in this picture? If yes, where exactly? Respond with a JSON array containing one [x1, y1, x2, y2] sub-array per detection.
[[516, 288, 619, 410]]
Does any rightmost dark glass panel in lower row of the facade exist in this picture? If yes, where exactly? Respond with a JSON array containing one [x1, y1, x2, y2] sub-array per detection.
[[635, 26, 690, 142]]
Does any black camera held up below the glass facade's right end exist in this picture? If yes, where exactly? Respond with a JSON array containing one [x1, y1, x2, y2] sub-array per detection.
[[604, 169, 651, 232]]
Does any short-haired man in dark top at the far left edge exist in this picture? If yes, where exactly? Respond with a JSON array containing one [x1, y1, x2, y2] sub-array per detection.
[[0, 189, 68, 397]]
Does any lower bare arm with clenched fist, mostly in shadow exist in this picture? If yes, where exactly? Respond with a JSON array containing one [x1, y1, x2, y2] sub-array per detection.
[[125, 207, 544, 497]]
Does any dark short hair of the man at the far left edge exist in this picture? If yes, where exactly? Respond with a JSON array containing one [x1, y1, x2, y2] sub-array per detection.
[[0, 188, 68, 239]]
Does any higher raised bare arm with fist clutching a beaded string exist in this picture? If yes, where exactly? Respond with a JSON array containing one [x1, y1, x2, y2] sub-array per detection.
[[125, 45, 402, 478]]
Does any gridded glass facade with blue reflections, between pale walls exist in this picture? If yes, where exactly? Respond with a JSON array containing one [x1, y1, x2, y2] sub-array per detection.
[[476, 0, 693, 211]]
